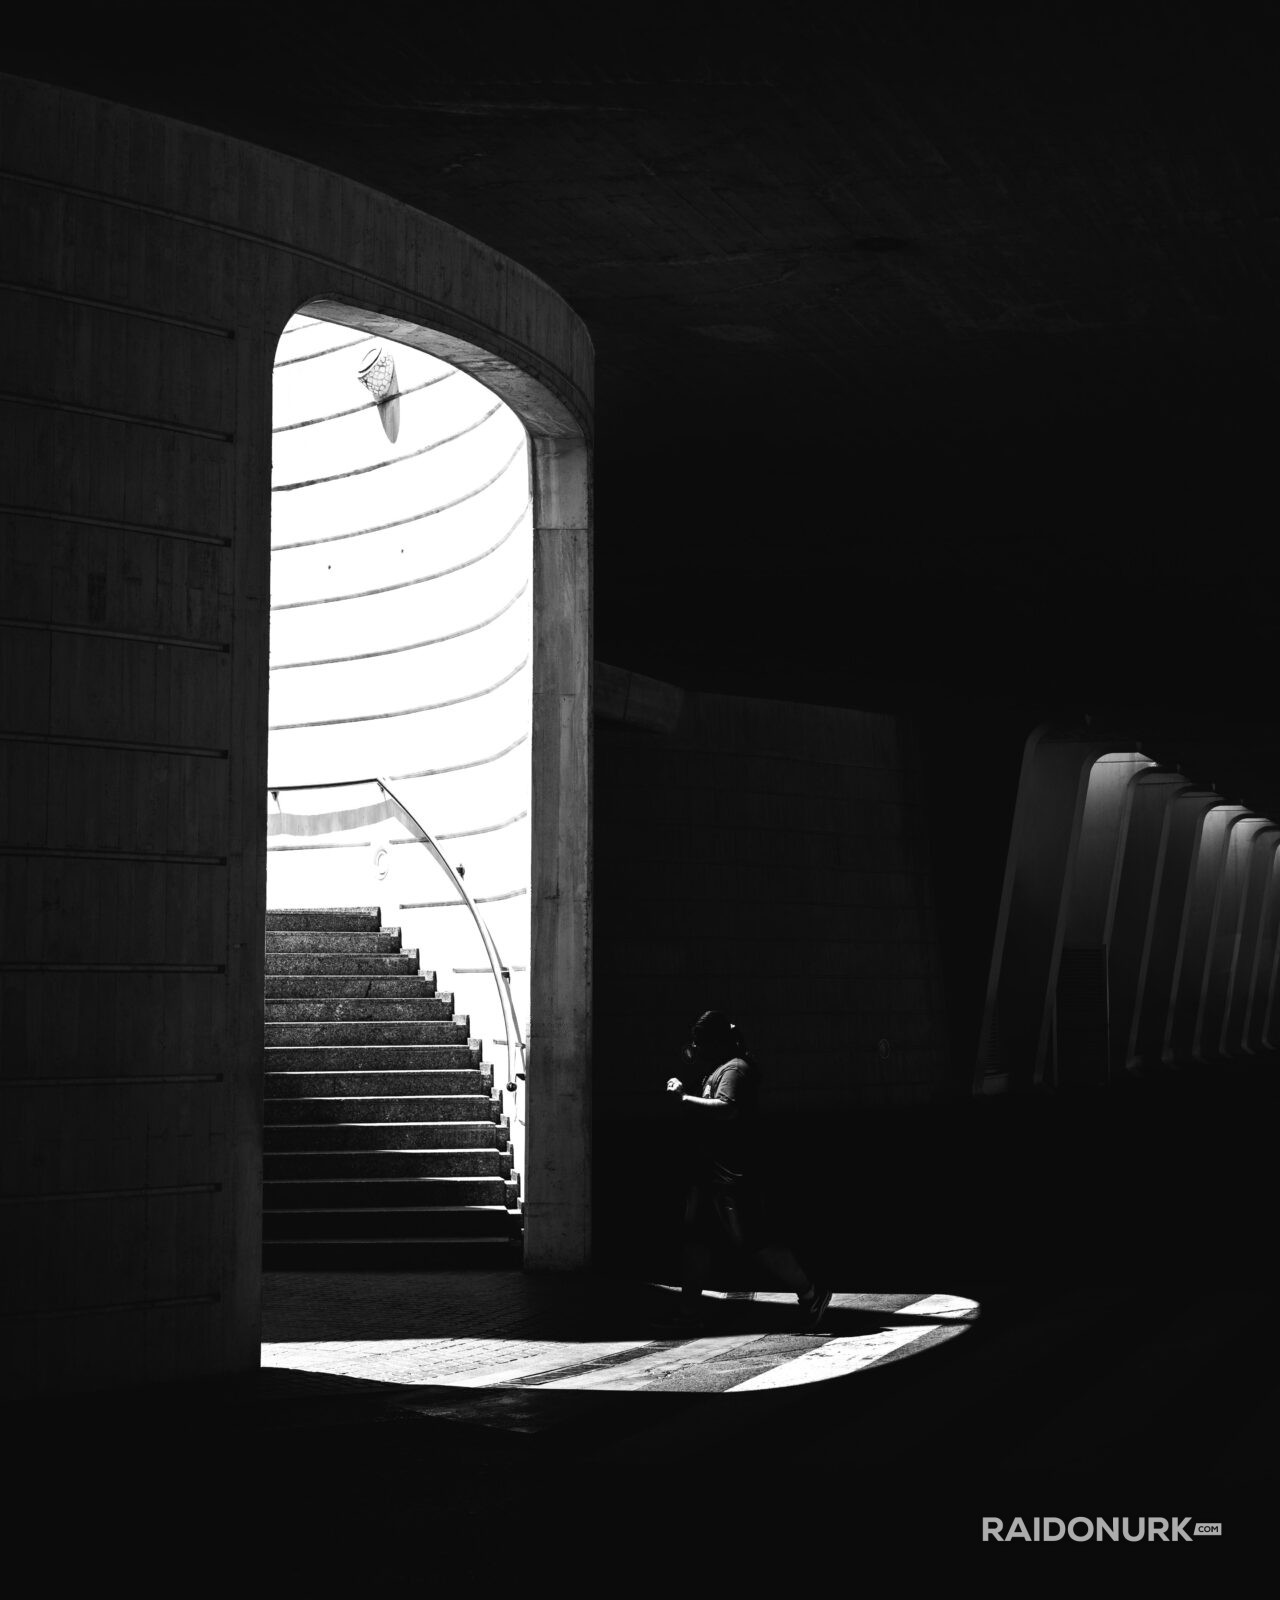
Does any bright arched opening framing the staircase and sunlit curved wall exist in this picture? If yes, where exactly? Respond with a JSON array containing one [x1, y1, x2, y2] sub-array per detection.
[[264, 315, 533, 1267]]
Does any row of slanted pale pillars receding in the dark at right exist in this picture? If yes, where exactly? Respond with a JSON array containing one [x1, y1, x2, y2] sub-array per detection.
[[974, 730, 1280, 1093]]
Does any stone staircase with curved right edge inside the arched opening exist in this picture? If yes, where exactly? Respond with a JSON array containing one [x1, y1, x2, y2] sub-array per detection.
[[262, 907, 522, 1270]]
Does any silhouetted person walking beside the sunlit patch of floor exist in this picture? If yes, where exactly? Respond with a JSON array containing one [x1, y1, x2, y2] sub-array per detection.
[[667, 1011, 830, 1330]]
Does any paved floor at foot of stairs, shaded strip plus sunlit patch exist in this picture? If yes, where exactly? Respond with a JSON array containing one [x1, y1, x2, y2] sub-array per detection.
[[262, 1272, 979, 1394]]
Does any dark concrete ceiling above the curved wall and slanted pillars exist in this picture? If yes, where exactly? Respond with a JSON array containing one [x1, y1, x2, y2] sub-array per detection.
[[5, 0, 1280, 787]]
